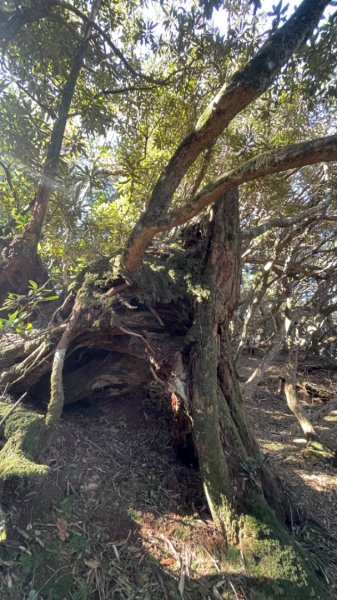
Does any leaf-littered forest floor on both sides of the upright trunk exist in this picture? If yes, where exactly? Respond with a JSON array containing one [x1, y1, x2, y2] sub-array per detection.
[[0, 357, 337, 600]]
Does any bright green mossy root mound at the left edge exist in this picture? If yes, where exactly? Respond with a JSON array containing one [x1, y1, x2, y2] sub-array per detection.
[[0, 402, 49, 483]]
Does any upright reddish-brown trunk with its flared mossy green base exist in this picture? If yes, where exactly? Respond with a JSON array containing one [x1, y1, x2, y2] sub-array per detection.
[[181, 189, 319, 600]]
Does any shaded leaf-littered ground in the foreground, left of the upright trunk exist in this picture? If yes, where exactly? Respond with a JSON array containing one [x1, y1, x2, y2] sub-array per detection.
[[0, 382, 333, 600]]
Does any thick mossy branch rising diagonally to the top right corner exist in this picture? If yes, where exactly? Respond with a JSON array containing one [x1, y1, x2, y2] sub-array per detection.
[[124, 0, 329, 272]]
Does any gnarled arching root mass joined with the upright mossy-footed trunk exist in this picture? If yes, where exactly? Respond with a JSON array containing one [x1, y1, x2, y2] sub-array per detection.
[[0, 224, 326, 599]]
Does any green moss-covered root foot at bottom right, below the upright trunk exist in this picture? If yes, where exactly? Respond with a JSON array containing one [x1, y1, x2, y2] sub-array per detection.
[[240, 497, 324, 600]]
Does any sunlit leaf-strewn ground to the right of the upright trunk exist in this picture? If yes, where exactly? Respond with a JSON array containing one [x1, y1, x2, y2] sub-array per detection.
[[240, 356, 337, 599]]
